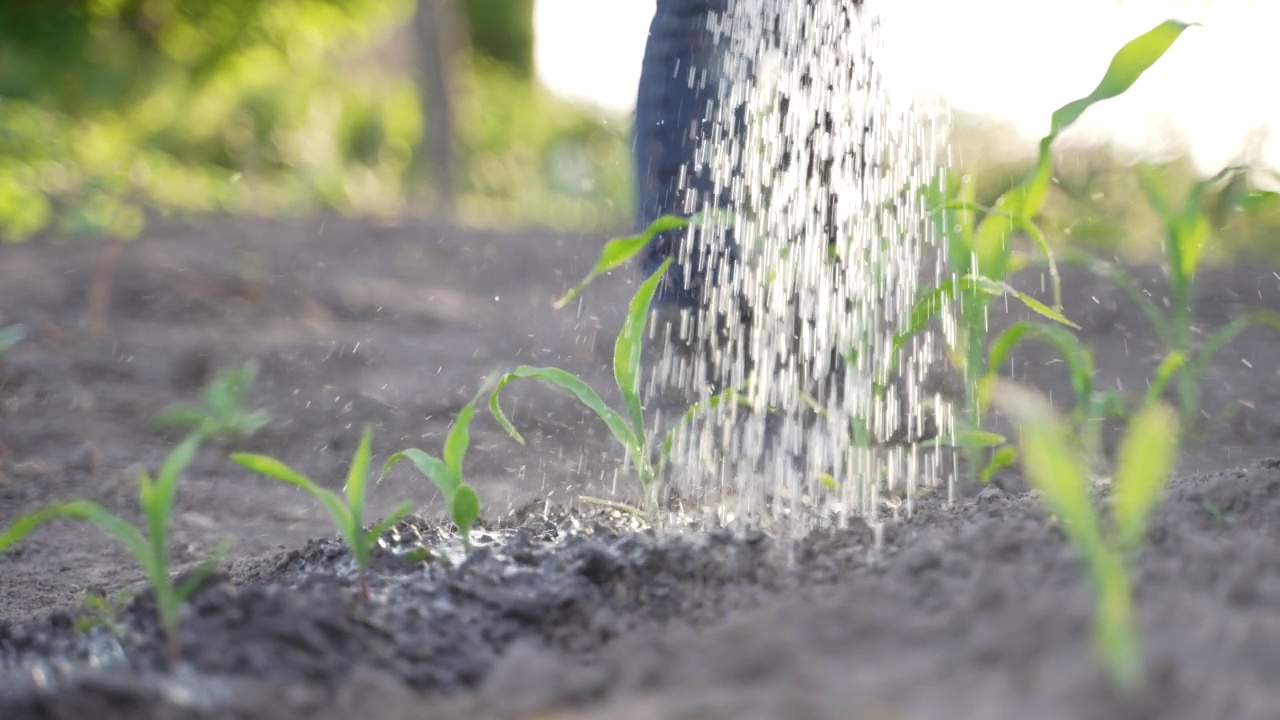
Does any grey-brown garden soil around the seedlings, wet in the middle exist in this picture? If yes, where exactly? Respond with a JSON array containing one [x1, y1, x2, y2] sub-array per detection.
[[0, 218, 1280, 720]]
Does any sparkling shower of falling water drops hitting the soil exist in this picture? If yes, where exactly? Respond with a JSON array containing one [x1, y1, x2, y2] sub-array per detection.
[[649, 0, 948, 533]]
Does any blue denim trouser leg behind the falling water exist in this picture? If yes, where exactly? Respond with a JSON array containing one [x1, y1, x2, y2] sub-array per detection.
[[634, 0, 731, 306]]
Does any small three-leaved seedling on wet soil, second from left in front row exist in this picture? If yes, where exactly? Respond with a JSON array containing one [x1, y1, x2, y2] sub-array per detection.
[[232, 427, 413, 602]]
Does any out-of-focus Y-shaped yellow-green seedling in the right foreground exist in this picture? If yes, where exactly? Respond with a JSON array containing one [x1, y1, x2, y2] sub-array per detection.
[[996, 384, 1178, 689]]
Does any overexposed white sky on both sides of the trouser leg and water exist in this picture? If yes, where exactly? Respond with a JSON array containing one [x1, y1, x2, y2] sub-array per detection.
[[534, 0, 1280, 173]]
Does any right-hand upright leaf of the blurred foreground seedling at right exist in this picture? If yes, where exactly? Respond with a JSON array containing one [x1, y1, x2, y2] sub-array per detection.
[[1111, 404, 1178, 551]]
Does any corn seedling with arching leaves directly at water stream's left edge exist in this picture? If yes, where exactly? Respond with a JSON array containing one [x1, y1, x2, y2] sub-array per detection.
[[489, 257, 739, 518]]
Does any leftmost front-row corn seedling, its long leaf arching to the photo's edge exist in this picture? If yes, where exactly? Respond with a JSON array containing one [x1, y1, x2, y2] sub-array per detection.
[[0, 433, 225, 661]]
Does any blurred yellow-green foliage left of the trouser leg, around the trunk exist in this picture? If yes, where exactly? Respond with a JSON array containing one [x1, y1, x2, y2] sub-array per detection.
[[0, 0, 628, 240]]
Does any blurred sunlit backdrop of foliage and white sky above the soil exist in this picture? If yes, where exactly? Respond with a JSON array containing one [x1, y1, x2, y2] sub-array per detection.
[[0, 0, 1280, 254]]
